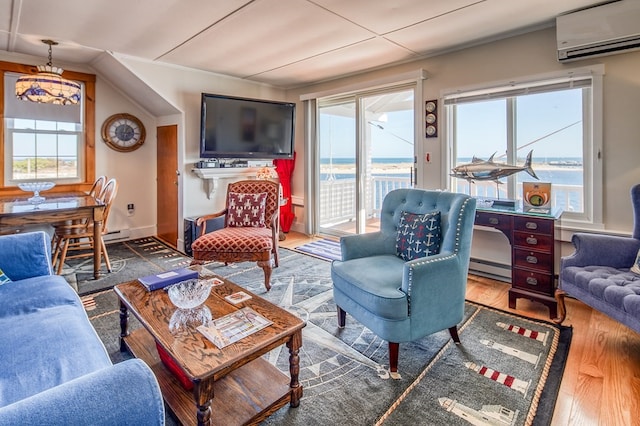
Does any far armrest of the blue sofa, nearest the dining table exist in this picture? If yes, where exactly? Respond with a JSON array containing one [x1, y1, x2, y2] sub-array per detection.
[[0, 231, 53, 281]]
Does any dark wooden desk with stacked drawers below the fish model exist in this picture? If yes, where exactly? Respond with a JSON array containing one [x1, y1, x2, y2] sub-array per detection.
[[475, 208, 562, 319]]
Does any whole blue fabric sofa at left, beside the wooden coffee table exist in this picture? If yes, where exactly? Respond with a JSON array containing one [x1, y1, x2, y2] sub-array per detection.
[[0, 232, 164, 425]]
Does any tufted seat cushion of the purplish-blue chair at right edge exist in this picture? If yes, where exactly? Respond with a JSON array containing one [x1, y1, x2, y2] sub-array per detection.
[[563, 266, 640, 317]]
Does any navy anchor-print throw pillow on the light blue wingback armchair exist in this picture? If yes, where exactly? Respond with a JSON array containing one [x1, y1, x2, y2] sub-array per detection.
[[396, 211, 442, 261]]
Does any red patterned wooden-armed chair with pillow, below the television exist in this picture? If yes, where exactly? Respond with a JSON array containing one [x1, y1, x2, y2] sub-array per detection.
[[191, 180, 280, 291]]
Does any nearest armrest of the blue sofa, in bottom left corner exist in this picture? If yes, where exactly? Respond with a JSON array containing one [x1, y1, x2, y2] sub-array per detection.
[[0, 359, 164, 426]]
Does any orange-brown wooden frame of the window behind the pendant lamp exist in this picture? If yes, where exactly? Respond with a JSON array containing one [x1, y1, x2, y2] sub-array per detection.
[[0, 61, 96, 196]]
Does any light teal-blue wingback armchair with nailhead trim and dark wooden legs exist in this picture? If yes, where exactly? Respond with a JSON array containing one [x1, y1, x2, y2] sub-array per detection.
[[331, 188, 476, 373]]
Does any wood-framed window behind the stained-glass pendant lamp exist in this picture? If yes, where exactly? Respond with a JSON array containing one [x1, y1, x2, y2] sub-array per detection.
[[0, 62, 95, 193]]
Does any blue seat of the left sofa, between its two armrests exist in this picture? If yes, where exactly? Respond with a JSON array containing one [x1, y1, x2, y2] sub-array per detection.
[[0, 276, 112, 407]]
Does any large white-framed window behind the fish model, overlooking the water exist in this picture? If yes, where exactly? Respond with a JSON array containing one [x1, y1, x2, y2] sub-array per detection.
[[445, 69, 601, 222]]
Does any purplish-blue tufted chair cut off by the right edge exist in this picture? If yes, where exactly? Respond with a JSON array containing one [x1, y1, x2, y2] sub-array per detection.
[[556, 184, 640, 333]]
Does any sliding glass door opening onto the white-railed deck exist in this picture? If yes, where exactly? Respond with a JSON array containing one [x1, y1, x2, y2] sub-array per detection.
[[316, 87, 415, 235]]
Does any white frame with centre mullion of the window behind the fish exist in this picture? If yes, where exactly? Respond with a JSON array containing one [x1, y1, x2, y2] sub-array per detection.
[[441, 65, 604, 229]]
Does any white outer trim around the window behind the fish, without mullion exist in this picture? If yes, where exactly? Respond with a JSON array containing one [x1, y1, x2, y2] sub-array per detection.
[[440, 64, 605, 230]]
